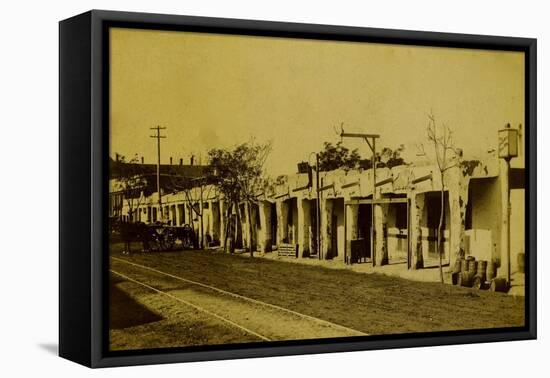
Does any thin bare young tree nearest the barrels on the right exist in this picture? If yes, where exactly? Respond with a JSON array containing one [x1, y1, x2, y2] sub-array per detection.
[[427, 112, 459, 283]]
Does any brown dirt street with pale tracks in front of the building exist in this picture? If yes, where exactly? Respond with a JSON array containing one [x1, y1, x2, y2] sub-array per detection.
[[110, 246, 525, 349]]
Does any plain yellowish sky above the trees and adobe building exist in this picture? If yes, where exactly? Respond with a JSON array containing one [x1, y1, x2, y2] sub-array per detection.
[[110, 28, 525, 176]]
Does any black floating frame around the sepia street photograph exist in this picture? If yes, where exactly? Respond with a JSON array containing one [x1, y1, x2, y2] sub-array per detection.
[[59, 10, 537, 367]]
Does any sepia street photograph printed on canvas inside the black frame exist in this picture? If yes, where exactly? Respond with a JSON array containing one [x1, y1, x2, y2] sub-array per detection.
[[106, 27, 529, 352]]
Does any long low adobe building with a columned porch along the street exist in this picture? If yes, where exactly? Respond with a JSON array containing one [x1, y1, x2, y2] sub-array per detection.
[[112, 146, 525, 280]]
